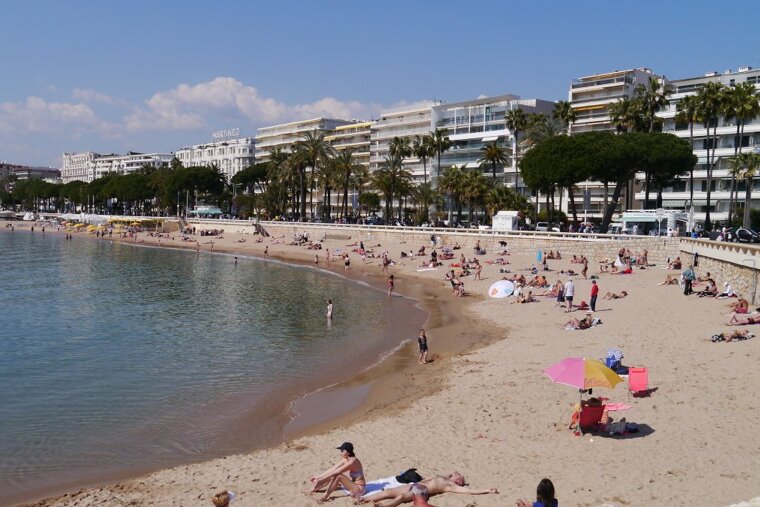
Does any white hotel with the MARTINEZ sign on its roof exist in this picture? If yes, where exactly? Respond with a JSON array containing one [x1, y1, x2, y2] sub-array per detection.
[[174, 136, 256, 181]]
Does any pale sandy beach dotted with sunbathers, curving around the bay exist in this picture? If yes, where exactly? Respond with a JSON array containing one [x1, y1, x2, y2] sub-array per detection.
[[7, 226, 760, 506]]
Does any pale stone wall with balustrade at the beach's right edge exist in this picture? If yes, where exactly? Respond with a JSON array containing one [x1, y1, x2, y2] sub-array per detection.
[[680, 239, 760, 304]]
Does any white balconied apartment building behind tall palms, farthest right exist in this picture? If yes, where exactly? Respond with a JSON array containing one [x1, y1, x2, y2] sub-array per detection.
[[652, 67, 760, 223]]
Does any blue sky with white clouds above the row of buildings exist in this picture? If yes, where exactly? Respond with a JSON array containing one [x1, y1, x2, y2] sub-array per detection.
[[0, 0, 760, 168]]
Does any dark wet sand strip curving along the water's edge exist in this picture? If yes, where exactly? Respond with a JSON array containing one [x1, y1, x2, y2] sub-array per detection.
[[0, 226, 504, 505]]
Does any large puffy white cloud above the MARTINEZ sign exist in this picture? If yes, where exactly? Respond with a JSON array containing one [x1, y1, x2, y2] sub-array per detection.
[[125, 77, 382, 131]]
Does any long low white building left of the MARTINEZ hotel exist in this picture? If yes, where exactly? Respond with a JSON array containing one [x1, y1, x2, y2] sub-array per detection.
[[61, 151, 173, 183]]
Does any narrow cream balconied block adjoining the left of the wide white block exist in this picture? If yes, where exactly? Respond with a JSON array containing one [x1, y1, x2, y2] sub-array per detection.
[[369, 101, 439, 182]]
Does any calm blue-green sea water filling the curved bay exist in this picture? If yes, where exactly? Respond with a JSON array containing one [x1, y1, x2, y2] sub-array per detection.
[[0, 230, 423, 503]]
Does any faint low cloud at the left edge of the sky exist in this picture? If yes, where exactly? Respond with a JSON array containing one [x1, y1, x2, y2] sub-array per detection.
[[0, 97, 118, 135]]
